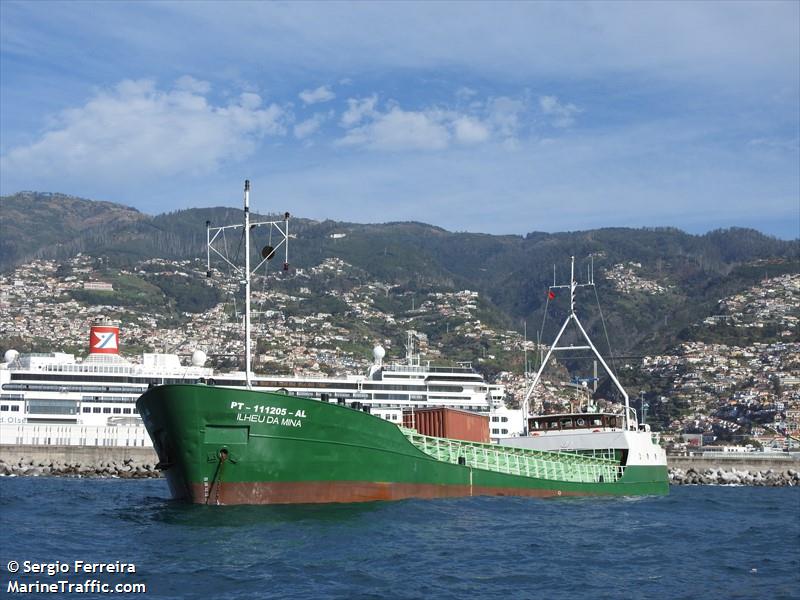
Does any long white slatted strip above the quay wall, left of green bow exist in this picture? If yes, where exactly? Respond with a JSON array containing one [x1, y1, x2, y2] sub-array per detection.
[[0, 423, 153, 448]]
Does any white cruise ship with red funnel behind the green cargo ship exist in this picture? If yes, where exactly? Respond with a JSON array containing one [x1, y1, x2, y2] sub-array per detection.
[[0, 323, 516, 446]]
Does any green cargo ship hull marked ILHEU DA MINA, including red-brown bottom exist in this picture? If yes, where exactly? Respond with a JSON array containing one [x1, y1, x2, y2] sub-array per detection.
[[137, 385, 669, 504]]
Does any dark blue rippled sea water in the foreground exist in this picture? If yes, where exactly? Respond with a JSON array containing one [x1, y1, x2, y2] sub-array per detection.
[[0, 477, 800, 600]]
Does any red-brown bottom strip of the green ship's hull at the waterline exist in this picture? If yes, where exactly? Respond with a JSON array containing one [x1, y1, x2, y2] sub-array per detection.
[[190, 481, 585, 505]]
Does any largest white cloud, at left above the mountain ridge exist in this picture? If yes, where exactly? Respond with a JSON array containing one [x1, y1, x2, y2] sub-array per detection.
[[2, 77, 286, 179]]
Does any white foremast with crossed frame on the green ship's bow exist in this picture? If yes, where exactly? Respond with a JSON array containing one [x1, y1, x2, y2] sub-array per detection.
[[206, 179, 289, 389]]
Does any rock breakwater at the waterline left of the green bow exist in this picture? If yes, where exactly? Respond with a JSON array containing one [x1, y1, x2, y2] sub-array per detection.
[[0, 458, 161, 479]]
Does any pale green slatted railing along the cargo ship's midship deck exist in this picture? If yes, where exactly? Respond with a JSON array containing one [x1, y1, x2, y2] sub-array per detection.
[[400, 427, 624, 483]]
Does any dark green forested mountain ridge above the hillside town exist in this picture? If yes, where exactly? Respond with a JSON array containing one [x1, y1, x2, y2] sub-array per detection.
[[0, 192, 800, 353]]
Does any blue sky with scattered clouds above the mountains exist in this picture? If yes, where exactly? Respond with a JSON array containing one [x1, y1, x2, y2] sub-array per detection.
[[0, 0, 800, 238]]
